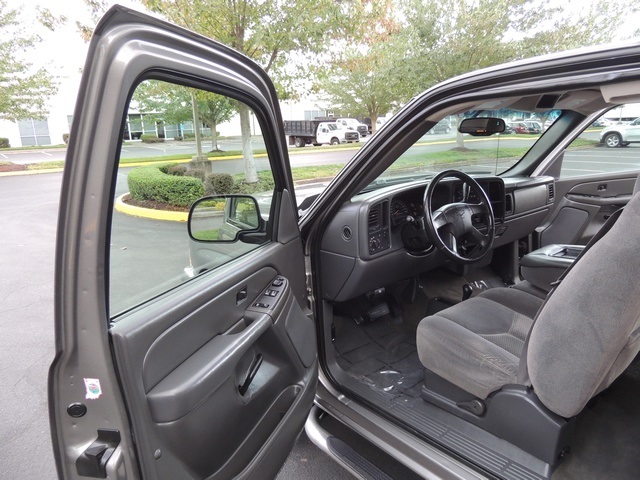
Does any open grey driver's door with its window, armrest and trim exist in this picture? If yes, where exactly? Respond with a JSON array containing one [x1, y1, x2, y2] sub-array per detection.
[[49, 7, 317, 479]]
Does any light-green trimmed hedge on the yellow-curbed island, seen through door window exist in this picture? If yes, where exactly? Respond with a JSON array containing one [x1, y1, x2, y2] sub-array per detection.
[[127, 166, 204, 207]]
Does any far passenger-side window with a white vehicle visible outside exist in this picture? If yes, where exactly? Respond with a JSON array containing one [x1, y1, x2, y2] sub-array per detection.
[[560, 104, 640, 178]]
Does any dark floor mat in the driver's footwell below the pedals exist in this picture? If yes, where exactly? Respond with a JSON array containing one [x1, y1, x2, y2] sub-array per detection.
[[334, 316, 424, 403]]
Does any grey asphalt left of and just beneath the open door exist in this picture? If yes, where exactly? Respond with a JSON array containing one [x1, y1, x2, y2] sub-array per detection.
[[0, 173, 349, 480]]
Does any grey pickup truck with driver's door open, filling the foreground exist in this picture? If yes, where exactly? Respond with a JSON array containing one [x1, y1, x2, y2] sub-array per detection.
[[48, 7, 640, 480]]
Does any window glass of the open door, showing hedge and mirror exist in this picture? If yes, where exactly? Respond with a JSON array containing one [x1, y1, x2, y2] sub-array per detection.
[[108, 80, 274, 318]]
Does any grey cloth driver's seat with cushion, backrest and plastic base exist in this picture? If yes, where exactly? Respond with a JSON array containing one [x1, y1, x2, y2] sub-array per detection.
[[417, 177, 640, 464]]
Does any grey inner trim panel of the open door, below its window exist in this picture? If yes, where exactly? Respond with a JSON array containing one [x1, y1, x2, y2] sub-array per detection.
[[110, 253, 315, 478]]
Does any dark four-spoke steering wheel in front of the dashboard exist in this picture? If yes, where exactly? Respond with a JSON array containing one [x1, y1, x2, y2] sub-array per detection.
[[424, 170, 496, 264]]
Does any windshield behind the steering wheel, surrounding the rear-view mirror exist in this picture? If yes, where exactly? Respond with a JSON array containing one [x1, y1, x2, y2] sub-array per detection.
[[378, 109, 560, 180]]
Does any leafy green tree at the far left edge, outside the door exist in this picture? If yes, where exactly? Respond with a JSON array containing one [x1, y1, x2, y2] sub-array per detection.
[[0, 0, 58, 122]]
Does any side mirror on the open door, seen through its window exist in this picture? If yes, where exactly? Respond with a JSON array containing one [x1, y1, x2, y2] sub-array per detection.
[[187, 195, 264, 243]]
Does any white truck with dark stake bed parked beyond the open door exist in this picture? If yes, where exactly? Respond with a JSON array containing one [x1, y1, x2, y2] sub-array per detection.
[[284, 120, 360, 147]]
